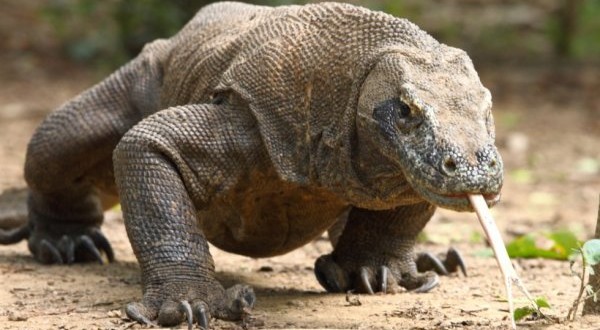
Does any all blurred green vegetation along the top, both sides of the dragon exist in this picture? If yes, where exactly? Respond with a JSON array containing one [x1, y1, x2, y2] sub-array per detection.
[[24, 0, 600, 69]]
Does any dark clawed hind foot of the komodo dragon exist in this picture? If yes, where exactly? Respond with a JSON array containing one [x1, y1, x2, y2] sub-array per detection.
[[28, 223, 114, 264]]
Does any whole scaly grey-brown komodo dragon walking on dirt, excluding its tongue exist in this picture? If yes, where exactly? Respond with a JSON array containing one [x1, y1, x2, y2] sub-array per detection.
[[0, 2, 502, 327]]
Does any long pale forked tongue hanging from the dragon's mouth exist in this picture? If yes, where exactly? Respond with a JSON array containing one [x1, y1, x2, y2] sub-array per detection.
[[469, 195, 539, 329]]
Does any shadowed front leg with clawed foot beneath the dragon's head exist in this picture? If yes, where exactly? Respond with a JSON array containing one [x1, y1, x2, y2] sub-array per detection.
[[315, 202, 460, 293]]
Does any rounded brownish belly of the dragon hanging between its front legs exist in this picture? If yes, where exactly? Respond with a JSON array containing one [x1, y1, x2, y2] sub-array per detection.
[[198, 176, 347, 257]]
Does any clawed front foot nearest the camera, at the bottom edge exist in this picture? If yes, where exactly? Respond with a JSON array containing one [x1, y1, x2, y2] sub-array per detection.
[[125, 284, 256, 329]]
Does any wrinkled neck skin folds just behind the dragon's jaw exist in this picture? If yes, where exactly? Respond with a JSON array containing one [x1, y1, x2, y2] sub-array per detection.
[[313, 49, 423, 210]]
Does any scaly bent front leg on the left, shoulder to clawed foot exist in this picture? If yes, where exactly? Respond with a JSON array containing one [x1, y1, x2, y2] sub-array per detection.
[[114, 105, 261, 328]]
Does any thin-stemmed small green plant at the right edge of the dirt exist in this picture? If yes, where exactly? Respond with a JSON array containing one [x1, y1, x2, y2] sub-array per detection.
[[567, 239, 600, 321]]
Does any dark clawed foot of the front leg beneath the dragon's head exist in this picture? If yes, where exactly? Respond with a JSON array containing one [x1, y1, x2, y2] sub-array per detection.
[[315, 248, 465, 294]]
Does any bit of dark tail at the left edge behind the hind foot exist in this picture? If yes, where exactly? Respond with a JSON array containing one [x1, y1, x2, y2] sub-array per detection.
[[0, 188, 30, 245]]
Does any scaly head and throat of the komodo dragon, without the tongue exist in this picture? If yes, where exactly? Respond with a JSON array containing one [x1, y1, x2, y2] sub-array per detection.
[[321, 45, 502, 211]]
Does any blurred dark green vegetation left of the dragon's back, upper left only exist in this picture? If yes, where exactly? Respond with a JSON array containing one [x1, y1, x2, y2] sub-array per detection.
[[40, 0, 210, 67]]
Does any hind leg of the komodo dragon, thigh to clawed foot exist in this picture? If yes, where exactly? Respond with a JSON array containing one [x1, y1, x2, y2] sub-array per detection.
[[9, 43, 169, 264]]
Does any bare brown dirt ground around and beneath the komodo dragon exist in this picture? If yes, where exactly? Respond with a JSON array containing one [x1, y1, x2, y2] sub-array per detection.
[[0, 52, 600, 329]]
